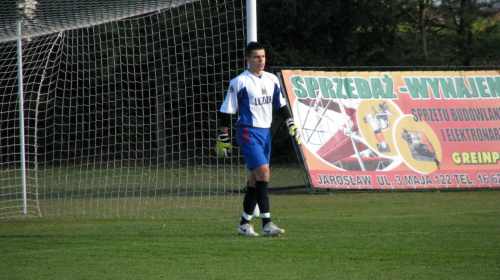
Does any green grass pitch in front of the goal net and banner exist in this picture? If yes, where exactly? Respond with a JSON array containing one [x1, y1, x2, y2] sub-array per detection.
[[0, 191, 500, 280]]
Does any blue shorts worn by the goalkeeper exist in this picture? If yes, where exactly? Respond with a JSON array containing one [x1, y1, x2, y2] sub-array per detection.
[[236, 126, 271, 170]]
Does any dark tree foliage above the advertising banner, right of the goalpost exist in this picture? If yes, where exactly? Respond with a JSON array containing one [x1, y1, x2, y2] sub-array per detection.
[[258, 0, 500, 67]]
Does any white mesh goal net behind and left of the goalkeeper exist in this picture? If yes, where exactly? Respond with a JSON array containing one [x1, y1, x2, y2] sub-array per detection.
[[0, 0, 246, 218]]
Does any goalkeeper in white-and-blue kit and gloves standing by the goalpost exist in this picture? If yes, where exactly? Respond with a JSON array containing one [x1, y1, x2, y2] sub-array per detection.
[[216, 42, 302, 236]]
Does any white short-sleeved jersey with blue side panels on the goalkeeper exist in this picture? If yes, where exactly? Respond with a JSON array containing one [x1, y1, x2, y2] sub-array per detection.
[[220, 70, 286, 128]]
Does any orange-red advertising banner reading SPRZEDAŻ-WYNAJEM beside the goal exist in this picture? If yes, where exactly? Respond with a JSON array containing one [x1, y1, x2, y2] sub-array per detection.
[[281, 70, 500, 189]]
